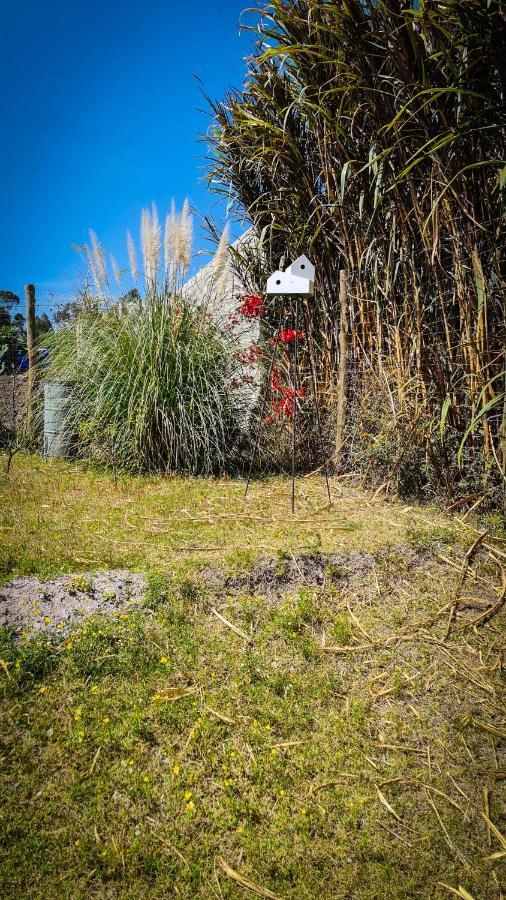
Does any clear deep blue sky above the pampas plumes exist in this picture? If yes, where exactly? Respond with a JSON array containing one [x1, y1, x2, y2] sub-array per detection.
[[0, 0, 251, 311]]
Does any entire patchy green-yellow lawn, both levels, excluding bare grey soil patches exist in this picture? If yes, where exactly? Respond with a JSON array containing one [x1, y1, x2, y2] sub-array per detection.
[[0, 457, 506, 900]]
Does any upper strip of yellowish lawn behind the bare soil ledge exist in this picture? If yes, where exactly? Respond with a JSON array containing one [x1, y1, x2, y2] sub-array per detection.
[[0, 455, 462, 580]]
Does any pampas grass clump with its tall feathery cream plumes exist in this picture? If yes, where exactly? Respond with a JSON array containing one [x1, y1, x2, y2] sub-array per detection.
[[39, 200, 245, 475]]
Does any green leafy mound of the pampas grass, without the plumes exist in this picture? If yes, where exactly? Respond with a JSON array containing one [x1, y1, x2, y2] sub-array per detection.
[[46, 293, 239, 474]]
